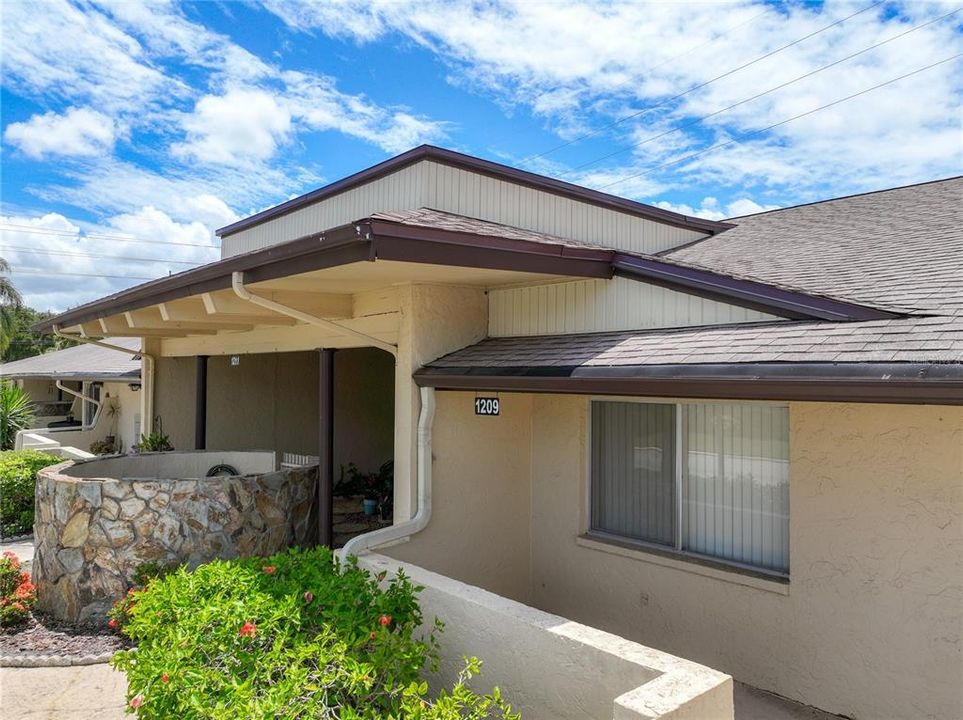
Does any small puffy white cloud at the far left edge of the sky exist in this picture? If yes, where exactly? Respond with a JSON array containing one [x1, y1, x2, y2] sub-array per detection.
[[3, 108, 117, 159]]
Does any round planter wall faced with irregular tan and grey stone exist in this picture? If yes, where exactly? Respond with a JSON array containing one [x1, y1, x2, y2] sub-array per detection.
[[33, 452, 317, 622]]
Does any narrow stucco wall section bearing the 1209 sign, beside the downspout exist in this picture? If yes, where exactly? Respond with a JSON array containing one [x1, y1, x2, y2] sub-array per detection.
[[381, 392, 532, 602]]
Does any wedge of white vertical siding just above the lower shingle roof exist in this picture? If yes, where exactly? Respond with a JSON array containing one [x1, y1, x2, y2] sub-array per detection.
[[488, 278, 779, 337]]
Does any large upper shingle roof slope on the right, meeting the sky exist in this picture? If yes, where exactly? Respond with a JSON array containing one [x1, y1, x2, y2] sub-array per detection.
[[662, 177, 963, 314]]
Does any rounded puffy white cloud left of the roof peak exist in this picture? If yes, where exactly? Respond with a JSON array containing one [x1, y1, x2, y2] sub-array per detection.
[[171, 89, 291, 165]]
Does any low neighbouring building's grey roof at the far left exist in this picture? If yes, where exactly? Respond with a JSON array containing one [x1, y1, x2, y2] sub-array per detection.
[[0, 337, 140, 381]]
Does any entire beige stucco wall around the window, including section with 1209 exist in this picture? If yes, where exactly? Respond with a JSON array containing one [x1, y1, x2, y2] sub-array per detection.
[[392, 392, 963, 720]]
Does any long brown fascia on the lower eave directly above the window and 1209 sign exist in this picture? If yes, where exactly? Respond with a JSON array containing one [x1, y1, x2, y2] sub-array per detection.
[[414, 363, 963, 405]]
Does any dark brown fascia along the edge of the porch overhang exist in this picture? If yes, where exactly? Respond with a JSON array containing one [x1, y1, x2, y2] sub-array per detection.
[[33, 220, 612, 332]]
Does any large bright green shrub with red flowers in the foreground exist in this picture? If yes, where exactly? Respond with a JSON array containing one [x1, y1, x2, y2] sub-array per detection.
[[112, 548, 517, 720]]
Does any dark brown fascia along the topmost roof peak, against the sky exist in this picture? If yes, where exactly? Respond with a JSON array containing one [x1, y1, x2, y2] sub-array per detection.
[[217, 145, 733, 238]]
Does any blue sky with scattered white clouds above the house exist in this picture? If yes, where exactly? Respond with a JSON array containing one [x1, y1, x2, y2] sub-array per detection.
[[0, 0, 963, 310]]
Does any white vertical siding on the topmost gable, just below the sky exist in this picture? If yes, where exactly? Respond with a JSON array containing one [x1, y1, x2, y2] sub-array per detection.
[[221, 160, 705, 257]]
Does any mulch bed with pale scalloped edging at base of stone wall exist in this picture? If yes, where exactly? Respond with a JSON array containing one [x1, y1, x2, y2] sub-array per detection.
[[0, 613, 130, 657]]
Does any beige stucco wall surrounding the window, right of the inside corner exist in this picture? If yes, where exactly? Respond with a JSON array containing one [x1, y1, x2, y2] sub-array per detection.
[[532, 396, 963, 719]]
